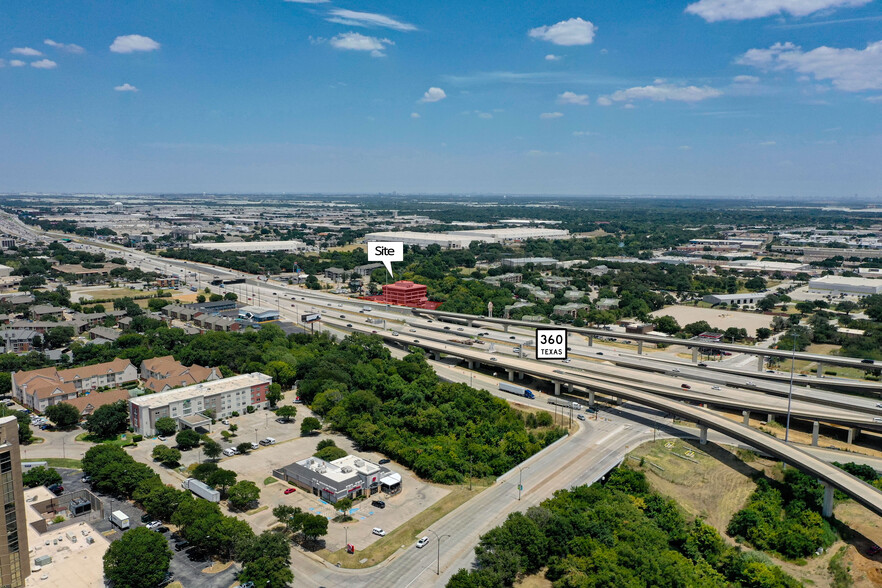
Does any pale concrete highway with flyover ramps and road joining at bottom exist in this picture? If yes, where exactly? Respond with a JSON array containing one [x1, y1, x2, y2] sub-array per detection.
[[0, 216, 882, 586]]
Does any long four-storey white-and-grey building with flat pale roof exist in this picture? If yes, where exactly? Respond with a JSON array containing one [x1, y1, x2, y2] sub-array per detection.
[[129, 372, 273, 436]]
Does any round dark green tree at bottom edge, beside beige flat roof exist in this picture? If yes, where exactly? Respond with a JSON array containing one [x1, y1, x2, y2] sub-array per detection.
[[104, 527, 172, 588]]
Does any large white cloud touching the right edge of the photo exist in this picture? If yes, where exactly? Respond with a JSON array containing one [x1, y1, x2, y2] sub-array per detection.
[[736, 41, 882, 92]]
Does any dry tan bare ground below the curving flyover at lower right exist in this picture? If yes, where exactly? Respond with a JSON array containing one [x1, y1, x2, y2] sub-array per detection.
[[626, 439, 882, 588]]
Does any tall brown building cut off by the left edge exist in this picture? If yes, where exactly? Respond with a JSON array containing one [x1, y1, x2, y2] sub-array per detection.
[[0, 416, 31, 588]]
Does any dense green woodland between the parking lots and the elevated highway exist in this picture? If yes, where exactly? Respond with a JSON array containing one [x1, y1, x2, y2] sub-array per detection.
[[297, 335, 564, 484]]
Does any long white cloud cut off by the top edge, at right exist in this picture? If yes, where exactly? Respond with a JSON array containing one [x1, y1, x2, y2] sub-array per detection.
[[686, 0, 872, 22]]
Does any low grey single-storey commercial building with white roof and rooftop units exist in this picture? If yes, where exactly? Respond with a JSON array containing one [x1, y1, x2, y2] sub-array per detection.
[[273, 455, 401, 504]]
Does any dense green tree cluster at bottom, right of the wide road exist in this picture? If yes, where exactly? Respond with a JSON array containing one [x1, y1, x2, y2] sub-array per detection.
[[447, 468, 800, 588]]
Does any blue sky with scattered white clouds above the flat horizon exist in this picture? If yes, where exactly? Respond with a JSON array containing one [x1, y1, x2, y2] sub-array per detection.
[[0, 0, 882, 199]]
